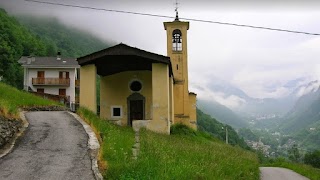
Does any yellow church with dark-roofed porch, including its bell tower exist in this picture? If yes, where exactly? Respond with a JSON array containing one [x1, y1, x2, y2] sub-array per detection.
[[77, 19, 197, 134]]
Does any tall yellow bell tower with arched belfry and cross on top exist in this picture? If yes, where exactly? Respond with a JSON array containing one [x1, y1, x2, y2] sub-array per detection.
[[164, 8, 196, 127]]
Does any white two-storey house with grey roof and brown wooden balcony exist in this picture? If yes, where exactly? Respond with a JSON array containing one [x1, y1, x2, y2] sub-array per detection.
[[19, 53, 80, 103]]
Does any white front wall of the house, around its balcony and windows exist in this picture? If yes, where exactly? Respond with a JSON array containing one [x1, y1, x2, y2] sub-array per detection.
[[25, 68, 76, 102]]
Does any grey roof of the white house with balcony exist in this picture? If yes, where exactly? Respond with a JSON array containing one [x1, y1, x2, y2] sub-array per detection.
[[18, 56, 80, 68]]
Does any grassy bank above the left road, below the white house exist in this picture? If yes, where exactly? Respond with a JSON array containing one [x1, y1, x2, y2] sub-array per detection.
[[0, 82, 58, 117]]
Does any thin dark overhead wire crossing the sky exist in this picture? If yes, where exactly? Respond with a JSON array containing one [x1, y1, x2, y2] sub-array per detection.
[[25, 0, 320, 36]]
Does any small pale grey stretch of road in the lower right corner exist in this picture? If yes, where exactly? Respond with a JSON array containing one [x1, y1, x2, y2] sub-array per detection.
[[260, 167, 308, 180]]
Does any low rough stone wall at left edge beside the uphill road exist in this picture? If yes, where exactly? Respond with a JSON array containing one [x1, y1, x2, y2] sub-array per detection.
[[0, 115, 22, 149]]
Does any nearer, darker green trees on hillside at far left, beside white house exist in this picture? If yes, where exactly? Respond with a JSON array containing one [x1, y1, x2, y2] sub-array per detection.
[[0, 9, 51, 88]]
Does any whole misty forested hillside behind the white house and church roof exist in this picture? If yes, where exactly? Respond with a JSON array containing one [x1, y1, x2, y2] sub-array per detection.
[[0, 8, 110, 89]]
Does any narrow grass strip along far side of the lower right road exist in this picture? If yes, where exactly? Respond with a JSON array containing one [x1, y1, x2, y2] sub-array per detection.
[[263, 158, 320, 180]]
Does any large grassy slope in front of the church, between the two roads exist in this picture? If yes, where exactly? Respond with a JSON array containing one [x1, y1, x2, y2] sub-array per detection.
[[78, 109, 259, 179]]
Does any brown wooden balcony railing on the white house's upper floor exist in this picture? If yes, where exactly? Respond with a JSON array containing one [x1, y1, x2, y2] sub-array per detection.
[[32, 78, 70, 86]]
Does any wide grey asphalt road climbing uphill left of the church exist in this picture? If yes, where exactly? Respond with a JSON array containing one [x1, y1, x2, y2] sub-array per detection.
[[0, 111, 94, 180]]
